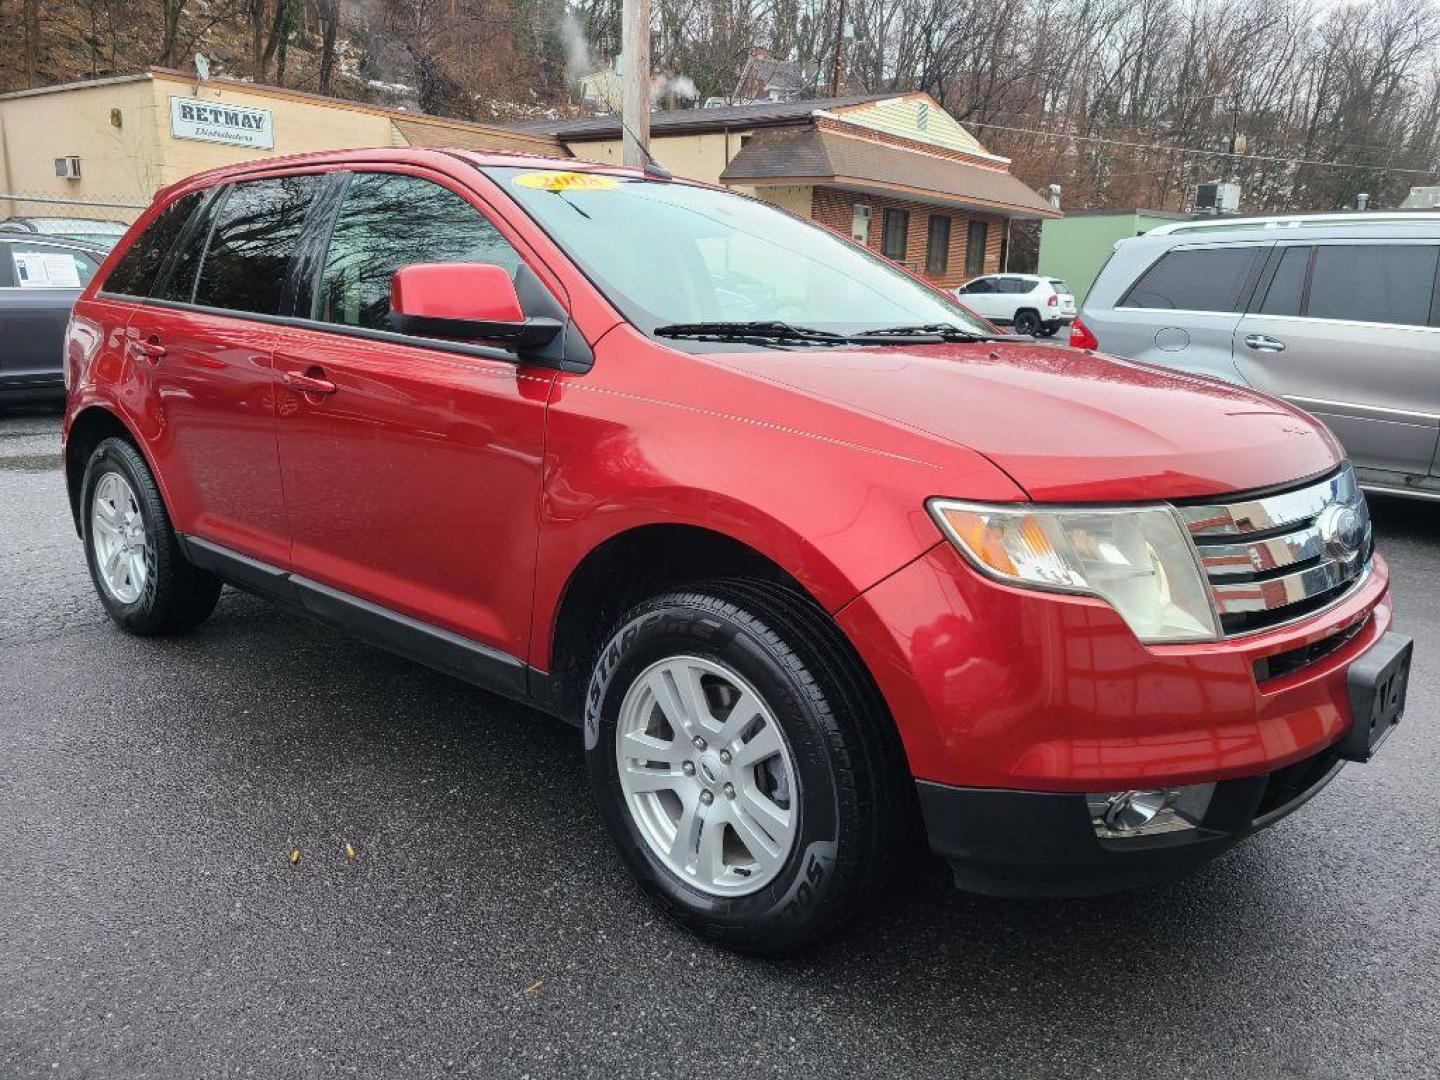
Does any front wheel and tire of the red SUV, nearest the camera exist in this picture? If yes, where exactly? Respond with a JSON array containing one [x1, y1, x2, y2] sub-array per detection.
[[585, 579, 914, 955]]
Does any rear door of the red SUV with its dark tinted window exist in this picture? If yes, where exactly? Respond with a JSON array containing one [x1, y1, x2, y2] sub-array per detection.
[[127, 174, 321, 567]]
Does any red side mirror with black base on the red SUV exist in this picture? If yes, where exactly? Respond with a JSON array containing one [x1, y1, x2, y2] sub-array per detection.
[[390, 262, 563, 353]]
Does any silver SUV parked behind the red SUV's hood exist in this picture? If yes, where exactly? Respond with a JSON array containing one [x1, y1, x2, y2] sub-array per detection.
[[1071, 213, 1440, 500]]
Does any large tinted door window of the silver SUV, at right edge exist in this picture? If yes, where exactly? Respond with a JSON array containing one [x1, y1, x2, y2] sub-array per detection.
[[1305, 243, 1440, 327]]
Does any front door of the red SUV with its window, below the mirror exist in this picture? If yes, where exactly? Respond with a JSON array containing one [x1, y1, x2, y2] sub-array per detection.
[[275, 171, 554, 657]]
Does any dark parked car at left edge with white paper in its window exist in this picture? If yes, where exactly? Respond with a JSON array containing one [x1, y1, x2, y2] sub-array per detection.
[[0, 232, 105, 400]]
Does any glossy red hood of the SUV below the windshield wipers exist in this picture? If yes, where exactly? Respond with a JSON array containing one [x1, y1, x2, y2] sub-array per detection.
[[710, 343, 1341, 503]]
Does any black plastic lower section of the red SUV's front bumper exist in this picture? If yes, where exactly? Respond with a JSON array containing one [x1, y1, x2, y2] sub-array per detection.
[[917, 747, 1345, 897]]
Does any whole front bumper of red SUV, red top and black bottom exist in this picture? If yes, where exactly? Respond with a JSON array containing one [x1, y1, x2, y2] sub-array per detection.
[[838, 544, 1391, 896]]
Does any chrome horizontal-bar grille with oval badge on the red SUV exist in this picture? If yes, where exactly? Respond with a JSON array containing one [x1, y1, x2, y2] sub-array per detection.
[[1175, 464, 1372, 635]]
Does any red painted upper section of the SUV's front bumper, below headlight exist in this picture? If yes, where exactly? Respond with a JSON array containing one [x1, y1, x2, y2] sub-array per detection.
[[837, 544, 1391, 793]]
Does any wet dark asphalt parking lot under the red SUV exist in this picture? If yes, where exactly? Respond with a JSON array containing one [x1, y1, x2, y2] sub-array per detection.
[[0, 409, 1440, 1080]]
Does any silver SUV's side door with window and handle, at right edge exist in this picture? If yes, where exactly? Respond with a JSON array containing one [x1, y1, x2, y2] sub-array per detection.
[[1233, 240, 1440, 478]]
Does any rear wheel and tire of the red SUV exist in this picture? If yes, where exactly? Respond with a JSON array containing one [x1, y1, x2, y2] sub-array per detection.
[[81, 438, 220, 636]]
